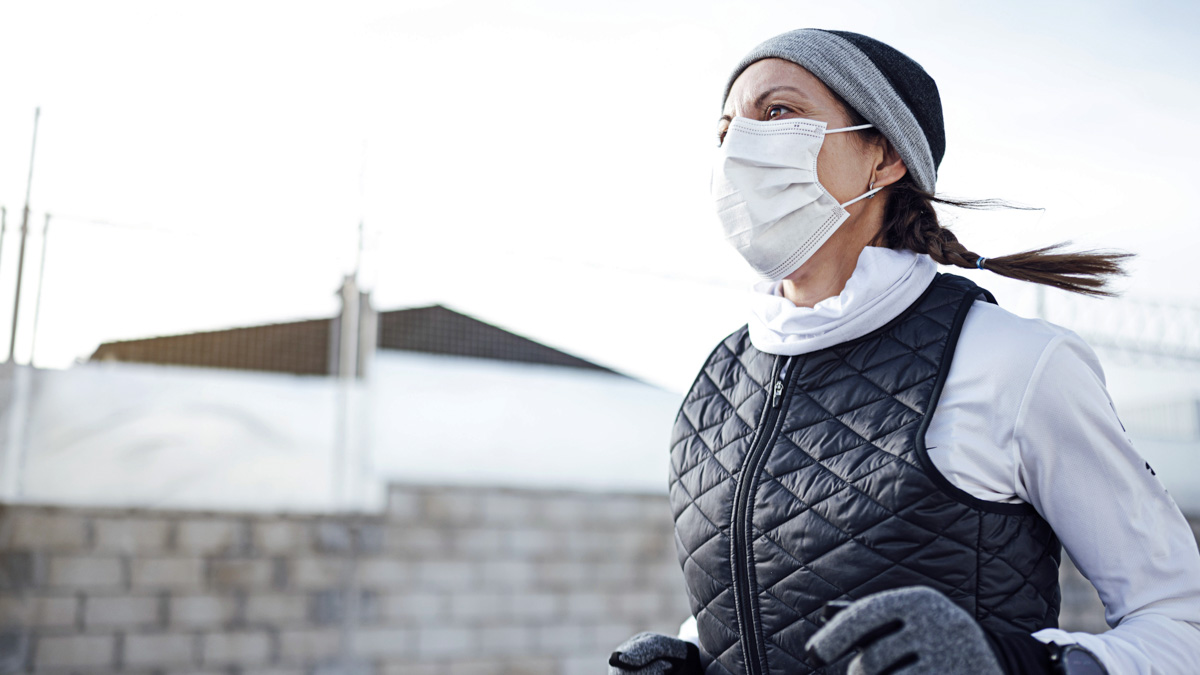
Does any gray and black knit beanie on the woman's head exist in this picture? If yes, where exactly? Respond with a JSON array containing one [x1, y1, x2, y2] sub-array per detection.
[[721, 28, 946, 193]]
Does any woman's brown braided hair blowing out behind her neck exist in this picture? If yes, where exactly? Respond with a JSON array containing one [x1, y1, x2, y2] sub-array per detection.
[[829, 97, 1134, 297]]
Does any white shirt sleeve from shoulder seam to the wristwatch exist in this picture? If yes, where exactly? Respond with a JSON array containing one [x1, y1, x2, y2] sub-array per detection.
[[1013, 333, 1200, 675]]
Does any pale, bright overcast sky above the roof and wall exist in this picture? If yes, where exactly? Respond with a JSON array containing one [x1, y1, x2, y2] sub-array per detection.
[[0, 0, 1200, 390]]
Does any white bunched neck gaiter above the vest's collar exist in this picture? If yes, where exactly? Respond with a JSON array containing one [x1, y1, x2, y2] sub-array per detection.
[[749, 246, 937, 356]]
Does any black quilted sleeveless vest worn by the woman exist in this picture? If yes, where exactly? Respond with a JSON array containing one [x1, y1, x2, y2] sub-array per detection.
[[671, 275, 1060, 675]]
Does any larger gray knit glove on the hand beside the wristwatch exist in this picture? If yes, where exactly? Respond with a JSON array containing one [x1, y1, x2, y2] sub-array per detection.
[[805, 586, 1004, 675]]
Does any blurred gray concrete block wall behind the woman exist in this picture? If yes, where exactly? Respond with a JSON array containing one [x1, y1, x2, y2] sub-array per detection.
[[0, 485, 1200, 675]]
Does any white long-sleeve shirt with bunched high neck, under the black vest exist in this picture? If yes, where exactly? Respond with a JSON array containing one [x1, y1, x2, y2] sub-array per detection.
[[680, 246, 1200, 675]]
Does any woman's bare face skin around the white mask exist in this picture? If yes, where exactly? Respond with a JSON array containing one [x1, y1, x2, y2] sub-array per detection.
[[718, 59, 875, 203]]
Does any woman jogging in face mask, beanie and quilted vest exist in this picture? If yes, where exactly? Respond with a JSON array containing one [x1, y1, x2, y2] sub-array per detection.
[[610, 29, 1200, 675]]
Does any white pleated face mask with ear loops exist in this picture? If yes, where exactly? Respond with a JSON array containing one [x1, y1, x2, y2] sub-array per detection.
[[712, 118, 883, 281]]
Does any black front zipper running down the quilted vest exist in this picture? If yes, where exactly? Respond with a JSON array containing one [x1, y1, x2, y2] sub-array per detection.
[[732, 357, 792, 675]]
